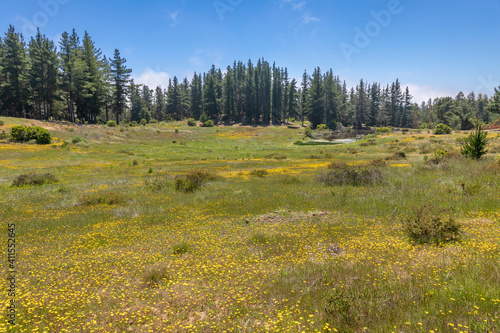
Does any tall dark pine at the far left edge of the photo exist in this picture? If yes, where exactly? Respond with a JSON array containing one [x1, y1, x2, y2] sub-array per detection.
[[0, 25, 31, 118]]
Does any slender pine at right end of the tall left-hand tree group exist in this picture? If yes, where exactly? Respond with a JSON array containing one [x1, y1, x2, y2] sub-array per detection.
[[111, 49, 132, 124]]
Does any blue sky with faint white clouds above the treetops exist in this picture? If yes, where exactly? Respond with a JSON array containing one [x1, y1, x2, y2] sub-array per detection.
[[0, 0, 500, 102]]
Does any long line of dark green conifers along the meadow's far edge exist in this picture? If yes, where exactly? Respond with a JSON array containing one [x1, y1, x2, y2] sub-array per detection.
[[0, 26, 500, 129]]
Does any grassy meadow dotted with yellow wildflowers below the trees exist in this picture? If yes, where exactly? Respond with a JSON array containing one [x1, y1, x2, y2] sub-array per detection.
[[0, 118, 500, 333]]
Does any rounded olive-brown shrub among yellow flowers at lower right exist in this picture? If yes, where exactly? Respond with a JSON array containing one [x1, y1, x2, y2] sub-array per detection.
[[402, 205, 461, 244]]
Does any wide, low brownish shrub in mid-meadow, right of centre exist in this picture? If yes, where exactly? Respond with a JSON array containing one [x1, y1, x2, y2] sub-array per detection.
[[318, 164, 383, 186]]
